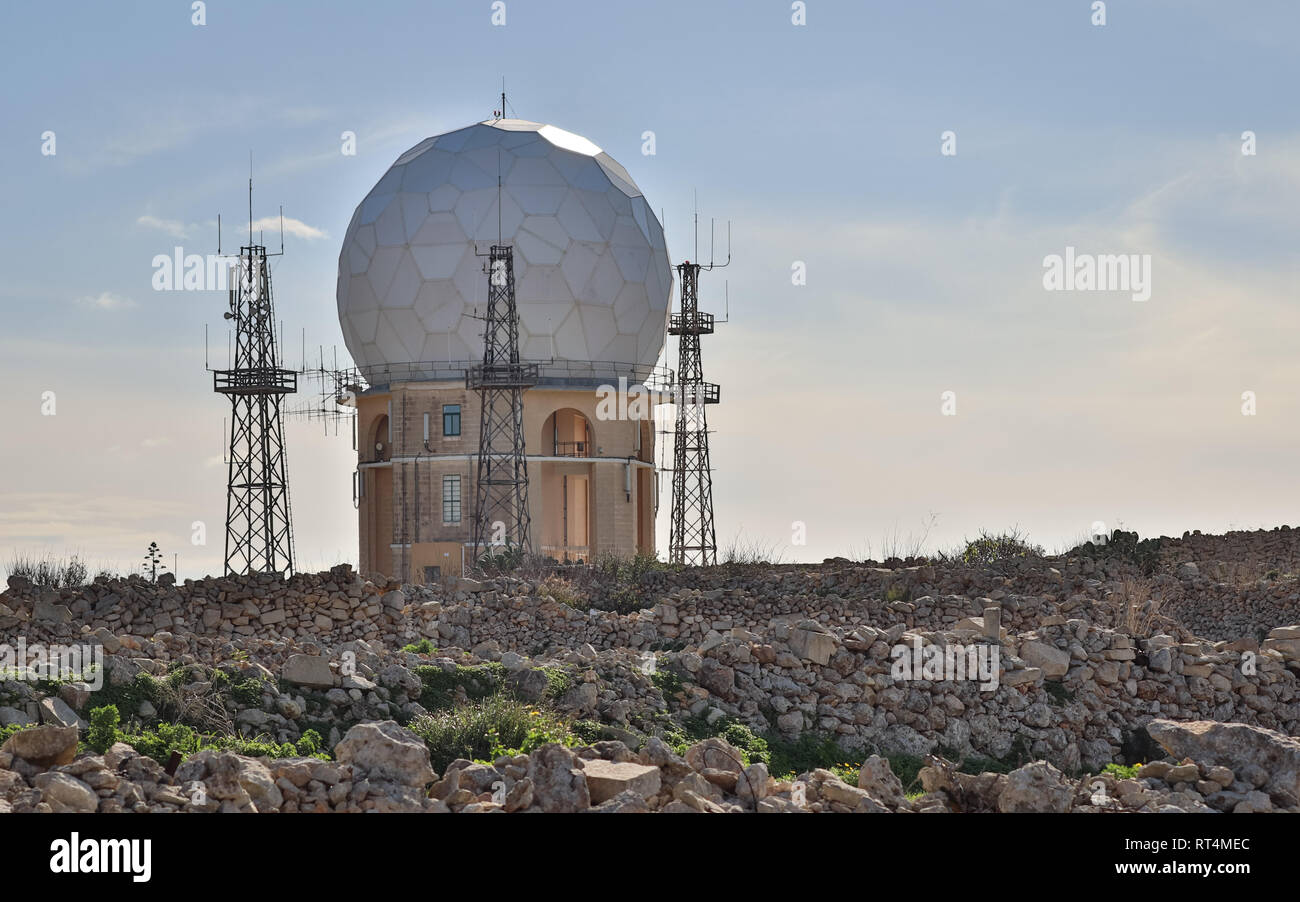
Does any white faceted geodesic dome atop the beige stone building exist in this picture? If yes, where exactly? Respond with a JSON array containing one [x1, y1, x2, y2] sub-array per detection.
[[338, 120, 672, 373]]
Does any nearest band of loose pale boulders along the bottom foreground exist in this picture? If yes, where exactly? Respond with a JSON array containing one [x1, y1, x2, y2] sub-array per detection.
[[0, 720, 1300, 814]]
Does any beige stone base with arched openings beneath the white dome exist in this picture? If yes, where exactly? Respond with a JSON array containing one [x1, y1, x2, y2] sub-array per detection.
[[358, 381, 658, 582]]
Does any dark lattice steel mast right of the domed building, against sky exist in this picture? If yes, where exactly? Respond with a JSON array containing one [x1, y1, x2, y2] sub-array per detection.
[[668, 257, 731, 565]]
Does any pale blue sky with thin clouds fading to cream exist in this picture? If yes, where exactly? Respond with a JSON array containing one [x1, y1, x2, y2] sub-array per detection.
[[0, 0, 1300, 578]]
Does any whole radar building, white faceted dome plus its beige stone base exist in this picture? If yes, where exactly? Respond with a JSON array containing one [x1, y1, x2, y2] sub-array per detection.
[[338, 120, 672, 582]]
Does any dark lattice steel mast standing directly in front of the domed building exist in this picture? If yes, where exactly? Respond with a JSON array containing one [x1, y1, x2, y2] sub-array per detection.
[[465, 244, 538, 565]]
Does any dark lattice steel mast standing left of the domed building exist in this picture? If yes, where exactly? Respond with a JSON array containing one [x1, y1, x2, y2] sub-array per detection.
[[213, 244, 298, 574]]
